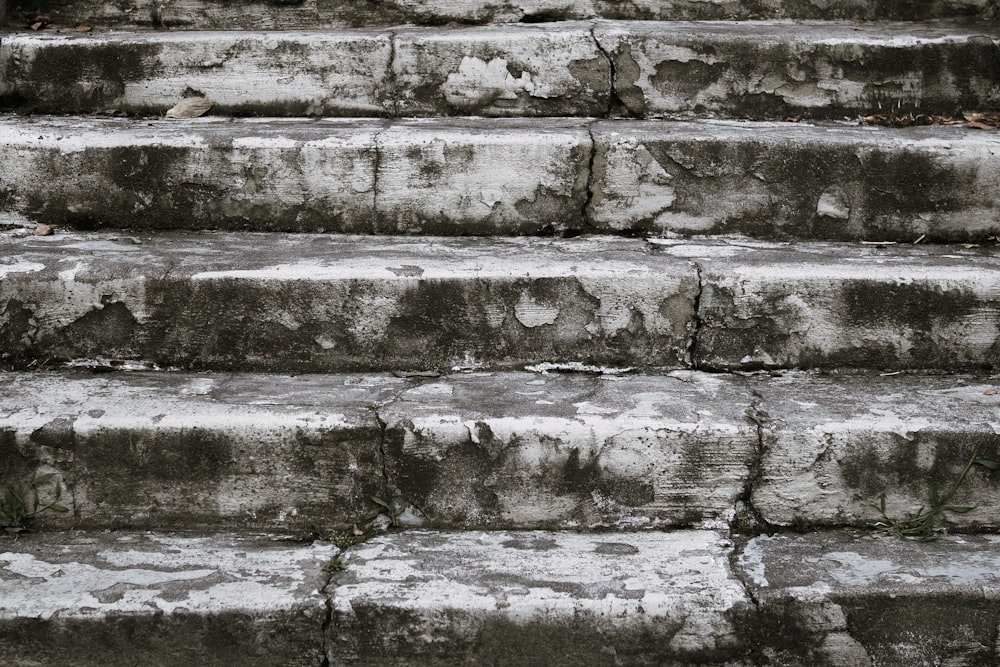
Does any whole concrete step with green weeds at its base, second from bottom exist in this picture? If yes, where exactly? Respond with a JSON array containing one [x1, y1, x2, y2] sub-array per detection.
[[0, 371, 1000, 536]]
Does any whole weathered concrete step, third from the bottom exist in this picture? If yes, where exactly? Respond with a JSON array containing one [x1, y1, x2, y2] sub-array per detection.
[[0, 231, 1000, 372]]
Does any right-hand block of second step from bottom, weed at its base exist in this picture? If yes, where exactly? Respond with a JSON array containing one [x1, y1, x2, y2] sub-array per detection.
[[751, 373, 1000, 530]]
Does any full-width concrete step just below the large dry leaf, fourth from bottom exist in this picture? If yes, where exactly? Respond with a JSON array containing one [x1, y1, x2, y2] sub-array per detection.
[[0, 117, 1000, 243]]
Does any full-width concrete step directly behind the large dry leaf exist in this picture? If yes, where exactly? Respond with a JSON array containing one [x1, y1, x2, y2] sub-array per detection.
[[0, 21, 1000, 119]]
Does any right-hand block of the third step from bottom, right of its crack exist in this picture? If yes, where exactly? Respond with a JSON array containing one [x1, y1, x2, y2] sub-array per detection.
[[657, 241, 1000, 371]]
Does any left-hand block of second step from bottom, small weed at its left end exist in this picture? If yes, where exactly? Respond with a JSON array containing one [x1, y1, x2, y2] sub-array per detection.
[[0, 373, 403, 533]]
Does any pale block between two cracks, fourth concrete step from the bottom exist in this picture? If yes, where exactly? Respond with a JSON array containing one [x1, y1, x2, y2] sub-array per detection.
[[375, 119, 592, 234]]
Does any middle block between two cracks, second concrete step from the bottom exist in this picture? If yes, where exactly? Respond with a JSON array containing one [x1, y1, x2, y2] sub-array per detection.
[[379, 372, 758, 529]]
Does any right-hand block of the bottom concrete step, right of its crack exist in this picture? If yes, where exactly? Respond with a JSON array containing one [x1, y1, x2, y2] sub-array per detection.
[[737, 533, 1000, 667]]
